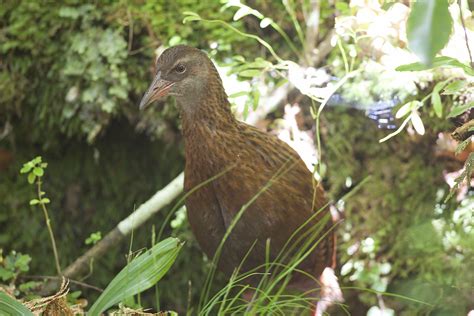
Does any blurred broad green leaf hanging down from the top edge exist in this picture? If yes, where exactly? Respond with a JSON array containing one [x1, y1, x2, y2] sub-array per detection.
[[407, 0, 452, 65]]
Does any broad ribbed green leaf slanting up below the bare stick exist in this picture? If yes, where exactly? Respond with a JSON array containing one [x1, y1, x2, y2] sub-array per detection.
[[87, 238, 182, 316]]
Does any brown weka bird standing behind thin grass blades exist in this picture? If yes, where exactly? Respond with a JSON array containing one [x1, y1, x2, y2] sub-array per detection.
[[140, 45, 334, 306]]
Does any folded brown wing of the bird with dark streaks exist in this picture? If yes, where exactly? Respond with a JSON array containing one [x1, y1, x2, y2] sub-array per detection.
[[213, 124, 334, 274]]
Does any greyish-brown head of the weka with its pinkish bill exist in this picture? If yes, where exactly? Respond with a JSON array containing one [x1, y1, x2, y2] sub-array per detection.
[[140, 45, 215, 109]]
